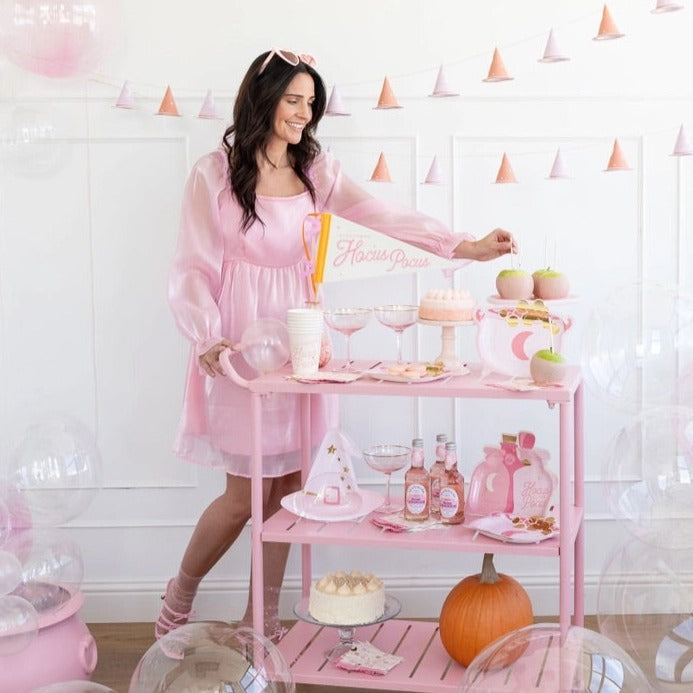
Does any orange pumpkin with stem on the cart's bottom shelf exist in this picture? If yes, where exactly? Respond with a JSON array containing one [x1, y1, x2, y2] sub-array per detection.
[[439, 553, 534, 667]]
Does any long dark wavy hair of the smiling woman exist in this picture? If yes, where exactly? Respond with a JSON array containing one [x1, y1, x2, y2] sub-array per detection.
[[223, 51, 327, 232]]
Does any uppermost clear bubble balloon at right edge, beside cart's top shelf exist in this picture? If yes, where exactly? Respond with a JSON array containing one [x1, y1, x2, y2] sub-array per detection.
[[582, 282, 693, 414]]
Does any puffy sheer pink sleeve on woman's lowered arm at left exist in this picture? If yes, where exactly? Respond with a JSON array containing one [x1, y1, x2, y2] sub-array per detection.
[[168, 151, 225, 356]]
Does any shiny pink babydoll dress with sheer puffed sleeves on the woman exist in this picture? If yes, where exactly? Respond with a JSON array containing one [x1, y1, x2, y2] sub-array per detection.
[[169, 149, 471, 477]]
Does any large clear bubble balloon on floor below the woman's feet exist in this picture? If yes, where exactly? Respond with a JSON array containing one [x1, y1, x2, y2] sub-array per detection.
[[129, 621, 295, 693]]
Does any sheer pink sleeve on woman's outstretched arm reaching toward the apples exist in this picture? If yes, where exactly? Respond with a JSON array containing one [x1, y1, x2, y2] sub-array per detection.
[[311, 153, 474, 264]]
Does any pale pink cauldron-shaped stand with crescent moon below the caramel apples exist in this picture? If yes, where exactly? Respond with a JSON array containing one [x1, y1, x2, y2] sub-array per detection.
[[474, 301, 572, 378]]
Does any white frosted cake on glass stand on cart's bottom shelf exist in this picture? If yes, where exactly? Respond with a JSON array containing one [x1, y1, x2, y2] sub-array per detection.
[[308, 570, 385, 626]]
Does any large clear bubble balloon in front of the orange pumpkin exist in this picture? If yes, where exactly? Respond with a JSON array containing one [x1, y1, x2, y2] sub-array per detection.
[[460, 623, 655, 693]]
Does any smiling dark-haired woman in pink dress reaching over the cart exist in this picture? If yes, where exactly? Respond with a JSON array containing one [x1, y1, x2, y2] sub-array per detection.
[[155, 49, 514, 639]]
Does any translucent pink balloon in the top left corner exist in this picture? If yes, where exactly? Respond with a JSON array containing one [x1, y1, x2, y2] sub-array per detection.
[[0, 0, 117, 77]]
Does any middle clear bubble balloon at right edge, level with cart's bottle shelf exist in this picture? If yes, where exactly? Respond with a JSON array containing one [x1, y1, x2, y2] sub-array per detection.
[[602, 406, 693, 548]]
